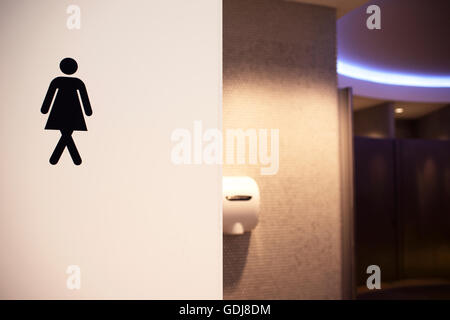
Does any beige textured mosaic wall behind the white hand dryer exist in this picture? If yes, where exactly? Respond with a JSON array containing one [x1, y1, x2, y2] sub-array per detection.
[[223, 0, 341, 299]]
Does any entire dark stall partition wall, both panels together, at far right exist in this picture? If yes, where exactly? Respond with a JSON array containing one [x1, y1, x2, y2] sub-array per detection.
[[354, 137, 450, 285]]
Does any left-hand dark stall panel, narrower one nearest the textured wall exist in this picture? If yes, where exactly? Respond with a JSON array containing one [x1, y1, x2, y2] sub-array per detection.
[[354, 137, 398, 285]]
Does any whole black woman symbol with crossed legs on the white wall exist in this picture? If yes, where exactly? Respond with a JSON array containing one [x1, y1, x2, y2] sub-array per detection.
[[41, 58, 92, 165]]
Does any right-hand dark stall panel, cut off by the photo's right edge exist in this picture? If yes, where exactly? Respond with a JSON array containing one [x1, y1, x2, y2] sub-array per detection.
[[397, 140, 450, 278]]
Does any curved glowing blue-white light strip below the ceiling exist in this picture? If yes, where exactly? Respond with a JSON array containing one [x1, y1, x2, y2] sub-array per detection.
[[337, 60, 450, 88]]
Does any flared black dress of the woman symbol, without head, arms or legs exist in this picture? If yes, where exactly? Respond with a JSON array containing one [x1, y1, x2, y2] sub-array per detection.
[[45, 88, 87, 131]]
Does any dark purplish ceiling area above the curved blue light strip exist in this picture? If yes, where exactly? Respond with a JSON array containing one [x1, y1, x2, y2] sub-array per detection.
[[337, 0, 450, 76]]
